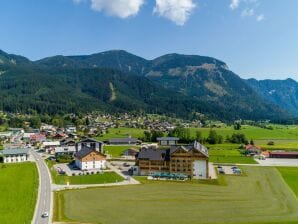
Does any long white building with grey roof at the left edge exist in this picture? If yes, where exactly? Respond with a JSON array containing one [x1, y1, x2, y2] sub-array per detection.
[[1, 148, 29, 163]]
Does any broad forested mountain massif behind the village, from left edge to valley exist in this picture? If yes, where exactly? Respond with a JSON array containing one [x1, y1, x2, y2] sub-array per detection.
[[0, 50, 290, 121]]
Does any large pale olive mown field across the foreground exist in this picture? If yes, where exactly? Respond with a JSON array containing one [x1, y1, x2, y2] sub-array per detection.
[[54, 167, 298, 224]]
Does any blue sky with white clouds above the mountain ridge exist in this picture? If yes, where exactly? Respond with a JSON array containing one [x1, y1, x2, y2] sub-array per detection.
[[0, 0, 298, 80]]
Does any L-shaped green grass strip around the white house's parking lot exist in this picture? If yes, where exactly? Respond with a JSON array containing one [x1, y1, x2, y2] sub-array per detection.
[[46, 160, 124, 185]]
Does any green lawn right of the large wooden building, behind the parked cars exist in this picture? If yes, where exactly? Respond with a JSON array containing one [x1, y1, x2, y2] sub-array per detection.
[[209, 144, 257, 164]]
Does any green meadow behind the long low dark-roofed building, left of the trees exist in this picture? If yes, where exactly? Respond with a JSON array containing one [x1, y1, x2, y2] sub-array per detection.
[[96, 127, 145, 141]]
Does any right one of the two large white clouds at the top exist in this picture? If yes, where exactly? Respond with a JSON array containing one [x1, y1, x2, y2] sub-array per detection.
[[154, 0, 196, 26]]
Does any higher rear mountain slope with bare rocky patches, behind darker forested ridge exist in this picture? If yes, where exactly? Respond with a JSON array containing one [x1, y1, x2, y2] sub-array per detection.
[[36, 51, 292, 120]]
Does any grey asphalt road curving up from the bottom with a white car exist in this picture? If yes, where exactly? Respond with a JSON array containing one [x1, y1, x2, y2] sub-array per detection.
[[31, 150, 51, 224]]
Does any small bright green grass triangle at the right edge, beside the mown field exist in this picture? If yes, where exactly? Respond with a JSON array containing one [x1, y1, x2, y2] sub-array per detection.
[[277, 167, 298, 197]]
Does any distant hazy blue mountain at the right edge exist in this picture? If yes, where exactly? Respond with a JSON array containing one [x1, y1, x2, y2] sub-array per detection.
[[246, 79, 298, 116]]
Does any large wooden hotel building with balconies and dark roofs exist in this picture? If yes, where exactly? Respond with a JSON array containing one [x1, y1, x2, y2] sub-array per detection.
[[136, 142, 209, 179]]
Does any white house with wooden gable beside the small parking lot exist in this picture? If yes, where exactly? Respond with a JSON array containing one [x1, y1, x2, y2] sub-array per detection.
[[75, 146, 106, 170]]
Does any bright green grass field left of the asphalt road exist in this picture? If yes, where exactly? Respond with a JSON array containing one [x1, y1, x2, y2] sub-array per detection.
[[0, 163, 38, 224]]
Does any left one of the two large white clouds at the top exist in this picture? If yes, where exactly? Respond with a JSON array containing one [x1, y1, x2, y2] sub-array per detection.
[[89, 0, 145, 19]]
